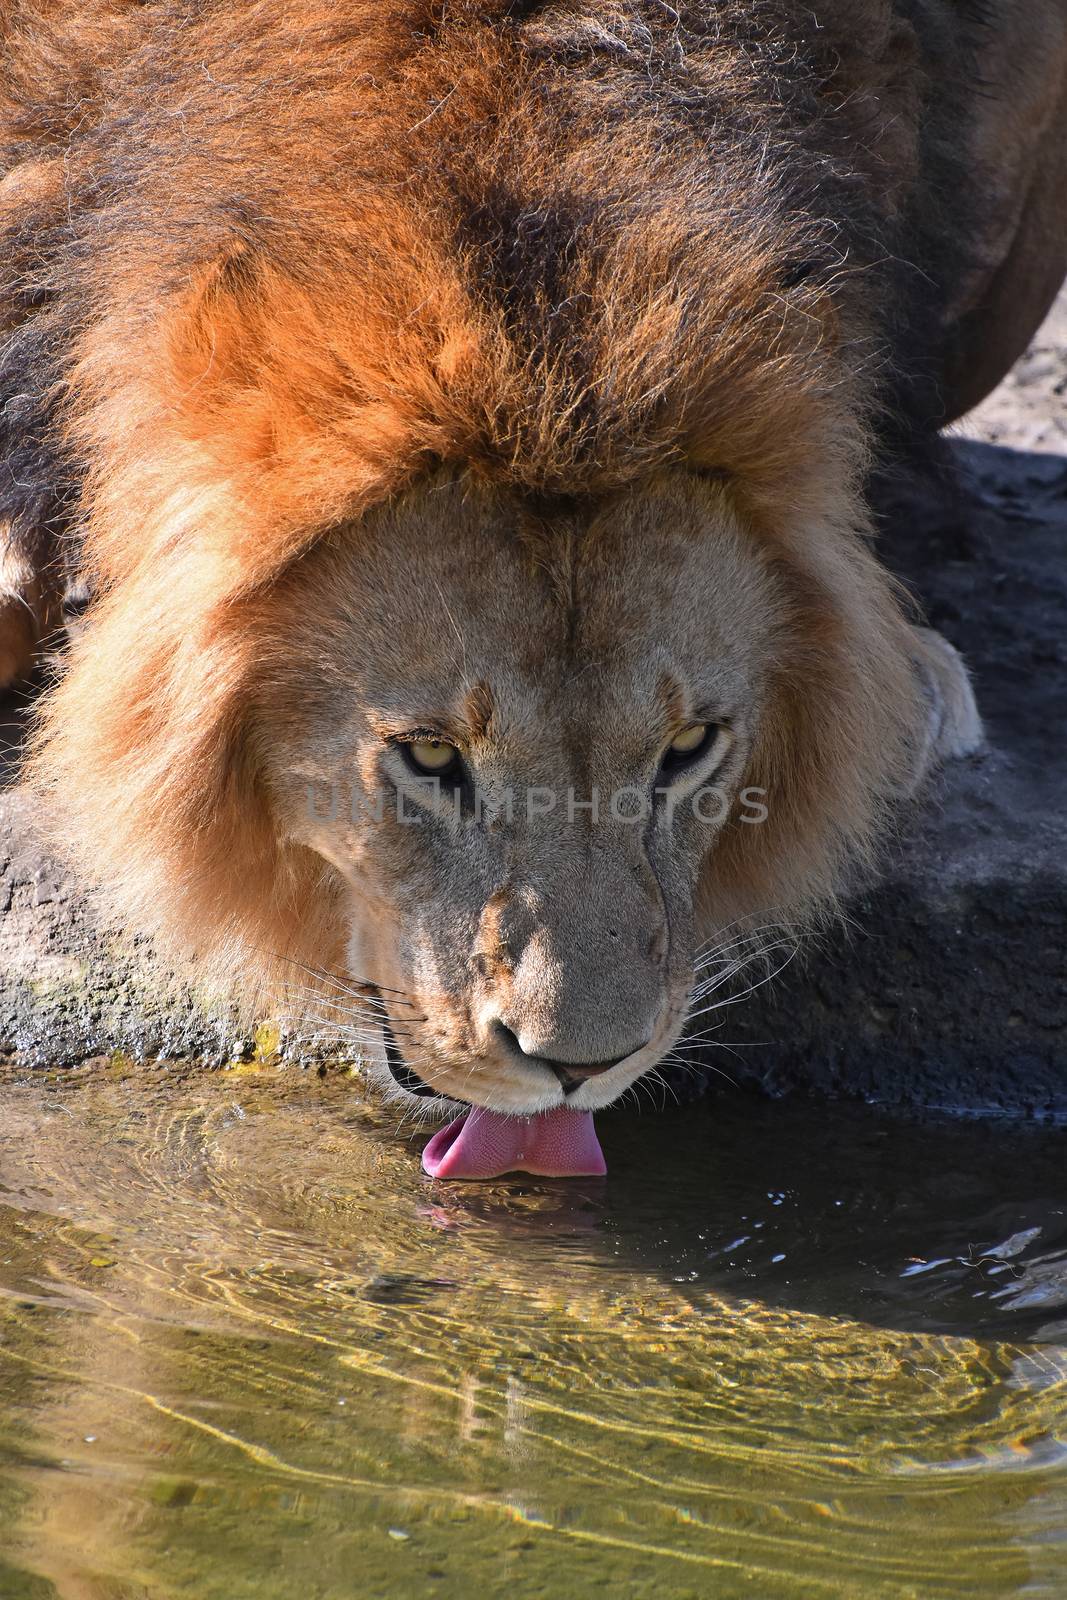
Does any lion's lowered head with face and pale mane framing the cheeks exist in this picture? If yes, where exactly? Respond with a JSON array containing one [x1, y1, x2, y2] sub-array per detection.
[[43, 444, 966, 1112]]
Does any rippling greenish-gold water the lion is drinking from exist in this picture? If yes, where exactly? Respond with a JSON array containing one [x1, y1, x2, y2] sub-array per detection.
[[0, 1064, 1067, 1600]]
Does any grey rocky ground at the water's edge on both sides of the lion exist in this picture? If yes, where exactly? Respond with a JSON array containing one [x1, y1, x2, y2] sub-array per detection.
[[0, 293, 1067, 1118]]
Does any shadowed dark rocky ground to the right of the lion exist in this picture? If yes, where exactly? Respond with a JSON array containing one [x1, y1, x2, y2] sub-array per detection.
[[739, 290, 1067, 1118]]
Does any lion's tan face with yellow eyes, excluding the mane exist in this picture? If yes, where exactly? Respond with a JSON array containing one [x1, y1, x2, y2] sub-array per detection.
[[263, 474, 781, 1112]]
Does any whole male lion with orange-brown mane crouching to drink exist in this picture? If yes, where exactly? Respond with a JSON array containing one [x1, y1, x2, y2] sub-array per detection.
[[0, 0, 1067, 1152]]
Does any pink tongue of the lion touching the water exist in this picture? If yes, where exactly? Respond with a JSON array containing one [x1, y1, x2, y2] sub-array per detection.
[[422, 1106, 608, 1178]]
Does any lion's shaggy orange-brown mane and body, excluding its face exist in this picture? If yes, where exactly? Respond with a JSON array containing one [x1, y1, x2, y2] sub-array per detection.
[[0, 0, 1067, 1113]]
